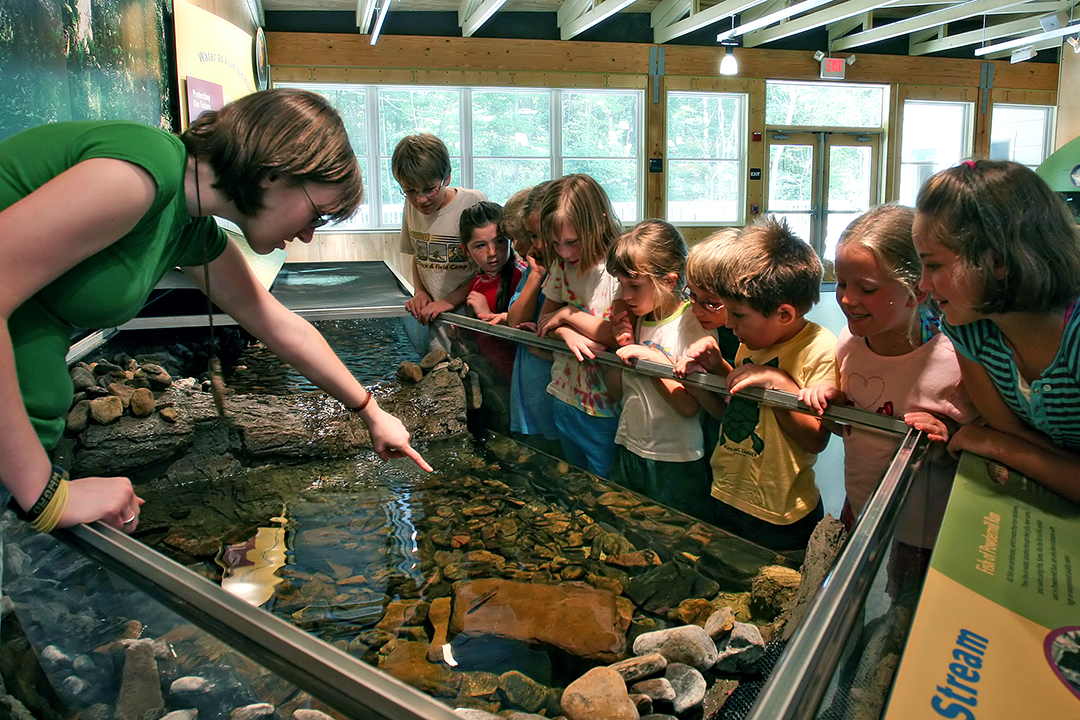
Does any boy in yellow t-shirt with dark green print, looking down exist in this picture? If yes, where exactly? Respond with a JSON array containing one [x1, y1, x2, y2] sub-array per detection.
[[679, 217, 837, 551]]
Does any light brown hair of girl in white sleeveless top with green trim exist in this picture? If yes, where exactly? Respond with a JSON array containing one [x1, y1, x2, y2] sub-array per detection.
[[607, 220, 687, 310]]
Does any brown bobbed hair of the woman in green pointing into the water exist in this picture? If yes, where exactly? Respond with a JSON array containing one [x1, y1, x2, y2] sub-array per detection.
[[180, 87, 364, 220]]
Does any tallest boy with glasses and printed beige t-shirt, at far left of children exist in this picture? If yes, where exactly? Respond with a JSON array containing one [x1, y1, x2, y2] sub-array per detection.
[[391, 133, 487, 355]]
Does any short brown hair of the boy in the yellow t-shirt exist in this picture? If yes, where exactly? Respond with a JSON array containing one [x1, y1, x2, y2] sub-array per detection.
[[711, 215, 822, 316]]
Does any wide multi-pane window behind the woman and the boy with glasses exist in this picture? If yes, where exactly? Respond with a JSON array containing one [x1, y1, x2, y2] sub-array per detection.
[[280, 83, 644, 231]]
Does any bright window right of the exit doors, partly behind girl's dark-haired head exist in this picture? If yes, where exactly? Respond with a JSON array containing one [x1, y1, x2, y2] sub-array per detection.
[[900, 100, 973, 207]]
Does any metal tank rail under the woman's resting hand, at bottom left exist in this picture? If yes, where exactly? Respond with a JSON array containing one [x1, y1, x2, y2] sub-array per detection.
[[55, 522, 460, 720]]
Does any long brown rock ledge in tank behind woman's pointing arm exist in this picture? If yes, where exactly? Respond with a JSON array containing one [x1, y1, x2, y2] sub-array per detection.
[[70, 364, 467, 477]]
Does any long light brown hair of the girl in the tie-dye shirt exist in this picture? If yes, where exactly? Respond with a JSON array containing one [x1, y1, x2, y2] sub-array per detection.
[[540, 174, 622, 271]]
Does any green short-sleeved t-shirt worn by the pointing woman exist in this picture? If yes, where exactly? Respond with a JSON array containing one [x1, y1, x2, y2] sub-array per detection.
[[0, 121, 228, 449]]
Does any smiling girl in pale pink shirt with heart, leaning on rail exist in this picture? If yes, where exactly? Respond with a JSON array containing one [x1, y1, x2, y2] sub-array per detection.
[[799, 205, 978, 570]]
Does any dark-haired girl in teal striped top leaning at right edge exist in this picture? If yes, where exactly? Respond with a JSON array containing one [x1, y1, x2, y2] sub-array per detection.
[[913, 160, 1080, 502]]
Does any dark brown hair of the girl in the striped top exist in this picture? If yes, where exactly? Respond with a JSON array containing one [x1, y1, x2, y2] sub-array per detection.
[[915, 160, 1080, 313]]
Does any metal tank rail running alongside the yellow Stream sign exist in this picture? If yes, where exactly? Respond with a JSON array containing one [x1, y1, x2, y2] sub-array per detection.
[[746, 429, 929, 720]]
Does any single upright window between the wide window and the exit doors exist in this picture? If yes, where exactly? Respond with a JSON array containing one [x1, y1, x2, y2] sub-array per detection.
[[667, 92, 746, 223]]
